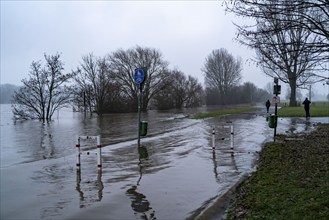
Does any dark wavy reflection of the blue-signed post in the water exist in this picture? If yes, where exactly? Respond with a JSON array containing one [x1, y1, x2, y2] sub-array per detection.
[[126, 146, 156, 219]]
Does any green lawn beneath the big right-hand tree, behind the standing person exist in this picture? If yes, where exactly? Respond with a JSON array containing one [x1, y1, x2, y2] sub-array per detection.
[[278, 102, 329, 117]]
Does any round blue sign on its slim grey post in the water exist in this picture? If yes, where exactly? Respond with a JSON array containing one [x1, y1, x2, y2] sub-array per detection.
[[134, 68, 146, 147]]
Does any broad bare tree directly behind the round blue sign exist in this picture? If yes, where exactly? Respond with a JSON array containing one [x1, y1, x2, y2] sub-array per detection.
[[108, 46, 169, 111]]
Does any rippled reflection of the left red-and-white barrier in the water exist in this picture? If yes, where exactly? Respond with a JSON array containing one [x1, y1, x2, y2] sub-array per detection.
[[76, 170, 104, 208]]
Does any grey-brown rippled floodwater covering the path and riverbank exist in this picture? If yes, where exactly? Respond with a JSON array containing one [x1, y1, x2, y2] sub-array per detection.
[[0, 105, 329, 219]]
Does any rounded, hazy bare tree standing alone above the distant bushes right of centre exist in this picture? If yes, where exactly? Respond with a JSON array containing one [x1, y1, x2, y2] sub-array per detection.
[[201, 48, 242, 104]]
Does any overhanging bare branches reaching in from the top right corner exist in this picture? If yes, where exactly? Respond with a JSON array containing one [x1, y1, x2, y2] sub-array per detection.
[[226, 0, 329, 61]]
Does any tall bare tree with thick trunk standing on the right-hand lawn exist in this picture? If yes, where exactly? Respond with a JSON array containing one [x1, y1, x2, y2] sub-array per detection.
[[226, 0, 329, 106]]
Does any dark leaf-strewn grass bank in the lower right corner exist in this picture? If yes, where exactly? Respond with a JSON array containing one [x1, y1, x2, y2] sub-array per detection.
[[227, 124, 329, 219]]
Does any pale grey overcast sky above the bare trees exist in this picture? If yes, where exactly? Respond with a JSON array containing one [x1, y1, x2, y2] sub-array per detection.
[[0, 0, 324, 97]]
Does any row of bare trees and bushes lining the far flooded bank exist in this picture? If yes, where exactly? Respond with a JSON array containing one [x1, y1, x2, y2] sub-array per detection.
[[9, 46, 270, 121]]
